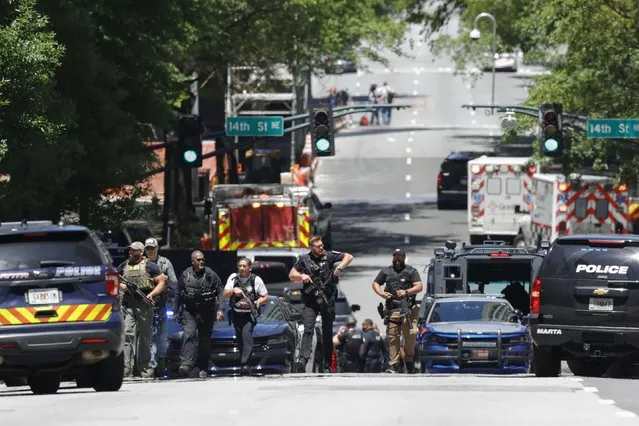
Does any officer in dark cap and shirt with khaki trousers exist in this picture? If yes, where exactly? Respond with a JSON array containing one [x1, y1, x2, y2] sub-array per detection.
[[373, 249, 423, 374]]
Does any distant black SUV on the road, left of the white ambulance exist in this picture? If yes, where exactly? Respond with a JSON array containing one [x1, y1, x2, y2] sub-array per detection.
[[437, 151, 486, 210]]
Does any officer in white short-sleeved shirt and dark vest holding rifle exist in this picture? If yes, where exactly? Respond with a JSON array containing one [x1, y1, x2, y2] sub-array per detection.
[[224, 257, 268, 375]]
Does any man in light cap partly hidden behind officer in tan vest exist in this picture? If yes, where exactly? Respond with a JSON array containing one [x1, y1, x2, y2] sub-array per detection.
[[144, 238, 177, 377]]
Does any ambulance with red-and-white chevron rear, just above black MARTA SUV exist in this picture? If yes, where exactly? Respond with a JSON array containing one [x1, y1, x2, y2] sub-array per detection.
[[527, 173, 630, 246]]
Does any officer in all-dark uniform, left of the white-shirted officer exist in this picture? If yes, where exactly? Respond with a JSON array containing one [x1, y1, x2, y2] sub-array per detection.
[[173, 250, 224, 378]]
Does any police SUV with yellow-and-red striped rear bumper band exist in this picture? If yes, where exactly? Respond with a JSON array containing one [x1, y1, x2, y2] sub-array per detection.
[[0, 221, 124, 394]]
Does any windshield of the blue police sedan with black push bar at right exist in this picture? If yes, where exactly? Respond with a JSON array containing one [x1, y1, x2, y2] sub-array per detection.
[[428, 300, 513, 323]]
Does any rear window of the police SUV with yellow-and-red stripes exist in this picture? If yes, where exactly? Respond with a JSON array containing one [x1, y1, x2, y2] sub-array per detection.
[[0, 232, 103, 271]]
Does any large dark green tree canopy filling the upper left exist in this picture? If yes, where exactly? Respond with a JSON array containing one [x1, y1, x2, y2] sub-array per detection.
[[0, 0, 409, 230]]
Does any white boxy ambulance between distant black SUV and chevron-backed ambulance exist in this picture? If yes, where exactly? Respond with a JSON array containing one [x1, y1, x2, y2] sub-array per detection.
[[468, 155, 537, 246]]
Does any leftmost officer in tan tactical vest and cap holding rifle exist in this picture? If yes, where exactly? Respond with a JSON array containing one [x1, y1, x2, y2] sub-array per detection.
[[118, 241, 166, 378]]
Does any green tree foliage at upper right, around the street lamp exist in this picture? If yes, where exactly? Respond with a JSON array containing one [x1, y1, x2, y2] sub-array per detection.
[[409, 0, 639, 184]]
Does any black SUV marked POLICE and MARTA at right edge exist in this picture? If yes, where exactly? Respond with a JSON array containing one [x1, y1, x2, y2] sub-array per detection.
[[529, 234, 639, 377]]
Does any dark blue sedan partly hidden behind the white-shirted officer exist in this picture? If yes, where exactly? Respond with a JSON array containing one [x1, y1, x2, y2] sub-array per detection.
[[167, 296, 301, 377]]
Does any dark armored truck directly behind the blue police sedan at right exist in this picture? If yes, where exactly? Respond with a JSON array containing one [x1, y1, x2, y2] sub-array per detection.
[[426, 240, 547, 302]]
